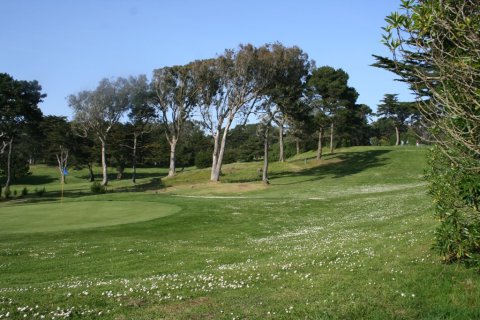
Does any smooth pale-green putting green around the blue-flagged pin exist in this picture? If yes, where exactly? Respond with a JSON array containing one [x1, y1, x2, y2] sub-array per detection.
[[0, 201, 181, 234]]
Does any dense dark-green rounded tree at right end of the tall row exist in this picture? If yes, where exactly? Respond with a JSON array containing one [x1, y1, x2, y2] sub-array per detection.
[[308, 66, 358, 152]]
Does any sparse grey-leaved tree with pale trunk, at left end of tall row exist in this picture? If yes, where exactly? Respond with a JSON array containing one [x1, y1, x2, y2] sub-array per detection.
[[68, 78, 130, 186]]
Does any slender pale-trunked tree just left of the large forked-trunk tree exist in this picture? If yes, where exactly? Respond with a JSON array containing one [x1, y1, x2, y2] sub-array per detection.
[[152, 65, 198, 176]]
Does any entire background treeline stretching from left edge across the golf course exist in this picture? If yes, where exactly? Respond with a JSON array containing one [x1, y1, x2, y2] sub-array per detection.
[[0, 43, 419, 187]]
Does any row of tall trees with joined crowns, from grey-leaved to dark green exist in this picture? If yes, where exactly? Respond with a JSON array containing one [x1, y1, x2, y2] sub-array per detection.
[[69, 43, 371, 185]]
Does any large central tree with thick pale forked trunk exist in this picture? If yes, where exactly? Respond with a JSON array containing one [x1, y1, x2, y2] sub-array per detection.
[[194, 44, 260, 181]]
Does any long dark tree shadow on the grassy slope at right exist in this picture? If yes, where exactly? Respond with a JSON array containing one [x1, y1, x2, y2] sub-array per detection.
[[269, 150, 391, 185]]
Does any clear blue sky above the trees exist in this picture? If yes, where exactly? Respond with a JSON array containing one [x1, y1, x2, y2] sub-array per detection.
[[0, 0, 410, 118]]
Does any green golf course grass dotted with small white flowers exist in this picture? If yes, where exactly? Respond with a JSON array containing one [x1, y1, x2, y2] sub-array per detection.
[[0, 147, 480, 320]]
